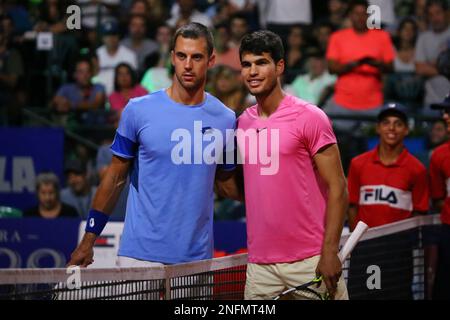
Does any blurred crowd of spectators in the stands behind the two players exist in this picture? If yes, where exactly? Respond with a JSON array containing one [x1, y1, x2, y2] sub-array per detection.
[[0, 0, 450, 218]]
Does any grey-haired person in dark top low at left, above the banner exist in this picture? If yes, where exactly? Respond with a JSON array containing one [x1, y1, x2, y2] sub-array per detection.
[[24, 172, 78, 219]]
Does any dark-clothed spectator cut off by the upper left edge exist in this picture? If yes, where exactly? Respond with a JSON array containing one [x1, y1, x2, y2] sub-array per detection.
[[0, 15, 24, 125]]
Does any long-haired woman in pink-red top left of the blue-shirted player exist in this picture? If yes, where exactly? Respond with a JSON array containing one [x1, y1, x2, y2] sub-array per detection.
[[109, 63, 148, 113]]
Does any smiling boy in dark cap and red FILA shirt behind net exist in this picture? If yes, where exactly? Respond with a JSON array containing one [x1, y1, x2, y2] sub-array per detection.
[[348, 104, 429, 299]]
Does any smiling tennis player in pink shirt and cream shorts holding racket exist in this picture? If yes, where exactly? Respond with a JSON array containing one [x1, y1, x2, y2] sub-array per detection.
[[237, 31, 348, 299]]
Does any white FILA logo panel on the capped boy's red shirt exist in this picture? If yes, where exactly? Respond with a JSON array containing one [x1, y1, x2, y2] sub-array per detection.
[[359, 185, 413, 211]]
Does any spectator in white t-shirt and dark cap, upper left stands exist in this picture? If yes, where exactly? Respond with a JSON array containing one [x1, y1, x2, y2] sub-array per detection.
[[97, 21, 137, 95]]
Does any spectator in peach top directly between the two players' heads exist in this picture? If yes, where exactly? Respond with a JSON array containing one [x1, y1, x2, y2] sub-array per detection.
[[214, 24, 241, 71]]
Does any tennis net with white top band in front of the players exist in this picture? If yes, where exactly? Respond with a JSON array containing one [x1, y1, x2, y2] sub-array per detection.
[[0, 215, 440, 300]]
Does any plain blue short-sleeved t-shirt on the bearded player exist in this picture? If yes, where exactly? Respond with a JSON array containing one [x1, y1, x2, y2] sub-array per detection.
[[111, 90, 236, 264]]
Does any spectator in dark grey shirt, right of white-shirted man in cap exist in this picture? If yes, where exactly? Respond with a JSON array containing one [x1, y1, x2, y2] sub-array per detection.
[[121, 15, 159, 74]]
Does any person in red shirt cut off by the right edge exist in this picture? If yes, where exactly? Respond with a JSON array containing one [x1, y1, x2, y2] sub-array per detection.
[[430, 95, 450, 300]]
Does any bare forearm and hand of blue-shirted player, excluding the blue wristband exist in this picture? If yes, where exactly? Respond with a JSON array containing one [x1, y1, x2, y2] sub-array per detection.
[[67, 156, 132, 267]]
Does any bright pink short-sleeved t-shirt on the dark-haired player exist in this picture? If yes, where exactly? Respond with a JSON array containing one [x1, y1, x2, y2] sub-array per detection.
[[237, 95, 336, 264]]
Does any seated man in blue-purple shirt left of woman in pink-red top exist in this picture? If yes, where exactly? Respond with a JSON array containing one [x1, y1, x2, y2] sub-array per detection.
[[52, 59, 105, 124]]
